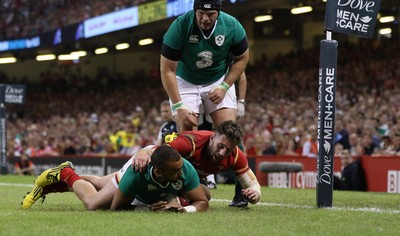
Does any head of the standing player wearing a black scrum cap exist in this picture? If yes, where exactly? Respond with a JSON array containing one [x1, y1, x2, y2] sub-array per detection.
[[193, 0, 222, 30]]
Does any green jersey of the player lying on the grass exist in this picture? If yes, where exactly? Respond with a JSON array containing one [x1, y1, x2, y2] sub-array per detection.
[[118, 159, 200, 204]]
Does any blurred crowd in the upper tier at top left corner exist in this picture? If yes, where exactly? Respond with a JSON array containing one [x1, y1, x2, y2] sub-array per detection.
[[0, 0, 150, 40]]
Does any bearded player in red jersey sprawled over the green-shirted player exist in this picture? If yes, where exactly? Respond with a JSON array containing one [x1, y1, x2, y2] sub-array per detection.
[[132, 121, 261, 204]]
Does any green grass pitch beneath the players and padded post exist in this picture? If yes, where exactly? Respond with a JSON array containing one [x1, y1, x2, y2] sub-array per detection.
[[0, 175, 400, 236]]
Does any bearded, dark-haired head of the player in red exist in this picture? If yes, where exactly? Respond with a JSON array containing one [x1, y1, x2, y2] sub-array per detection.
[[208, 121, 243, 162]]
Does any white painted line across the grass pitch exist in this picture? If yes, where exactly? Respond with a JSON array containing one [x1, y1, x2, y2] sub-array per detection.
[[0, 182, 400, 214]]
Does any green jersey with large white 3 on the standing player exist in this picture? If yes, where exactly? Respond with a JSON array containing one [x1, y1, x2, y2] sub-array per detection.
[[163, 10, 246, 84]]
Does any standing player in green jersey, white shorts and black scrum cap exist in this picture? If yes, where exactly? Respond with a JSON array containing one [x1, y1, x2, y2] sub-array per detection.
[[160, 0, 249, 207]]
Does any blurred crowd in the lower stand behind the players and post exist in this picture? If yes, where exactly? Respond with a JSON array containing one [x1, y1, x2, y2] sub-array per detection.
[[0, 39, 400, 157]]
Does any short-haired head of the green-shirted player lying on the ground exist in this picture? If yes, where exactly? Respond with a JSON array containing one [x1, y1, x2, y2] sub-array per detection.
[[151, 145, 183, 183]]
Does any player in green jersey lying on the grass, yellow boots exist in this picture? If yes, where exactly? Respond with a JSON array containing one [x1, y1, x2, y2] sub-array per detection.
[[22, 145, 209, 212]]
